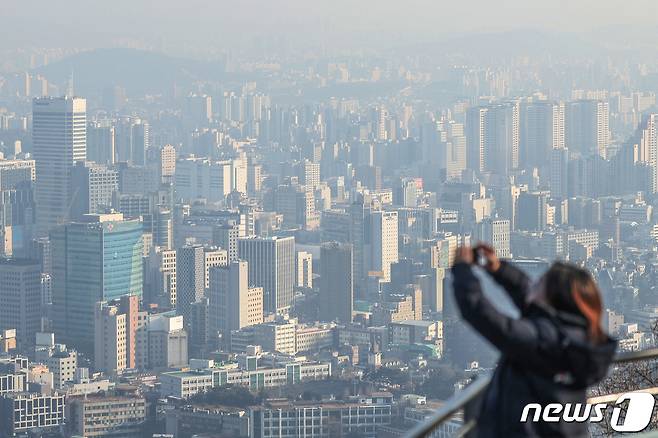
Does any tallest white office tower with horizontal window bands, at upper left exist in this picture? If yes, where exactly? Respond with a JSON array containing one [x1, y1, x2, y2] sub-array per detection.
[[32, 97, 87, 234]]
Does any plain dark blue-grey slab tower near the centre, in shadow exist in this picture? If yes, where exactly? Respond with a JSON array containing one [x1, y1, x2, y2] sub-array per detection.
[[320, 242, 354, 324]]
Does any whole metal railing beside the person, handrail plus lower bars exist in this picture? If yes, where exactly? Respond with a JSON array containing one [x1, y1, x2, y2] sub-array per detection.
[[405, 348, 658, 438]]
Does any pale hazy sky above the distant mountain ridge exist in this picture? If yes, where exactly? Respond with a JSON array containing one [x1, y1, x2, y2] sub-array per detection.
[[0, 0, 658, 51]]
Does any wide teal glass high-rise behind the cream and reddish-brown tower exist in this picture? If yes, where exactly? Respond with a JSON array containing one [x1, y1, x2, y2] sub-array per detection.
[[50, 213, 144, 353]]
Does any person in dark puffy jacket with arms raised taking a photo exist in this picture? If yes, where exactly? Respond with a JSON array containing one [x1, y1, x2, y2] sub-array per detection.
[[452, 244, 616, 438]]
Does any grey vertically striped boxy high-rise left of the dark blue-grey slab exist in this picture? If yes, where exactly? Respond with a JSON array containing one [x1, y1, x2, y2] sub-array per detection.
[[238, 236, 295, 313]]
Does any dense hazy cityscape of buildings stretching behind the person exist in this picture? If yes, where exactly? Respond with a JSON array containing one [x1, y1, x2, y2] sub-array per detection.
[[0, 1, 658, 438]]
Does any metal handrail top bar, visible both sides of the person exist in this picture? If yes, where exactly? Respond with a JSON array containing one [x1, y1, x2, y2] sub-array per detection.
[[406, 348, 658, 438]]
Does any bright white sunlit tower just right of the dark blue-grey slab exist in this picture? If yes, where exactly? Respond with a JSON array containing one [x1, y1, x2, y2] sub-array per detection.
[[367, 211, 398, 282]]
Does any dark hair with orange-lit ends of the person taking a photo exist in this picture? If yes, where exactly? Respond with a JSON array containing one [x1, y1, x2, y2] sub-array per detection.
[[543, 262, 605, 343]]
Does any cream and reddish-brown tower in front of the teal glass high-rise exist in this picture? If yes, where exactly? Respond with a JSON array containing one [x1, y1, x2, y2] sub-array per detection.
[[94, 295, 139, 374]]
